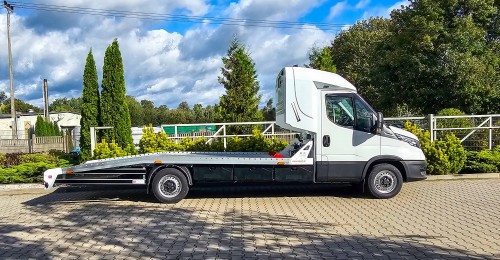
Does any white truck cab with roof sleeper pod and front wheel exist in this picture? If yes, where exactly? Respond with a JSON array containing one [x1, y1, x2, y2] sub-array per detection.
[[276, 67, 426, 198]]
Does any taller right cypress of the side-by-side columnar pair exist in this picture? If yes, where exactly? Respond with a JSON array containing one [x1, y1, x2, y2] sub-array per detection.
[[100, 39, 133, 148]]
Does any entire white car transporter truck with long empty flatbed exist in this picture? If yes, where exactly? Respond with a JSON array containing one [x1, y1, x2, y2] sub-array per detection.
[[44, 67, 426, 203]]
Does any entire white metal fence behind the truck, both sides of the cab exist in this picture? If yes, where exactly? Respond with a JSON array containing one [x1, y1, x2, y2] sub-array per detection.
[[86, 114, 500, 154]]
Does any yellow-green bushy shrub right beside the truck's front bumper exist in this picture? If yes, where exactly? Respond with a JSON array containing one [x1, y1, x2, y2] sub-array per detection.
[[405, 122, 466, 174]]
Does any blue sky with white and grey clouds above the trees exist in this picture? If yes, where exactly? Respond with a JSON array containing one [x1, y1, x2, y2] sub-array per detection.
[[0, 0, 407, 108]]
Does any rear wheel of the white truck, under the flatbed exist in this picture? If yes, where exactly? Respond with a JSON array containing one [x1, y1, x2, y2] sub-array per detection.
[[152, 168, 189, 203]]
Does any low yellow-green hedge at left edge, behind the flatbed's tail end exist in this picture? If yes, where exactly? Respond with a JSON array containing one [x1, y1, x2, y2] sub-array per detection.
[[0, 151, 75, 184]]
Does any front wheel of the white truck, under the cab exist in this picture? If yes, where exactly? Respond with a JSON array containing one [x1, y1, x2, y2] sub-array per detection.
[[367, 163, 403, 199]]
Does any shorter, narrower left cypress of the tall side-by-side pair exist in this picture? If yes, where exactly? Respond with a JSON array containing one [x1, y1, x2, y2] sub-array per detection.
[[80, 49, 99, 160]]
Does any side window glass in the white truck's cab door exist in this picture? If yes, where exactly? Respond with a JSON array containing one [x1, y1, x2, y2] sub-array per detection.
[[326, 95, 355, 129]]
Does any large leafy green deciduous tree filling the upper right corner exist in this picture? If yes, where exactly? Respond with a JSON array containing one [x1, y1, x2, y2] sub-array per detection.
[[376, 0, 500, 113]]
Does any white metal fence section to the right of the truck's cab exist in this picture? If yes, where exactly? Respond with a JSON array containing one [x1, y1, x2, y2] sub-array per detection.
[[385, 114, 500, 150]]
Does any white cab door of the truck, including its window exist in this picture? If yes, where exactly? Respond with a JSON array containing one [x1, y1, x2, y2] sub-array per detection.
[[316, 93, 381, 181]]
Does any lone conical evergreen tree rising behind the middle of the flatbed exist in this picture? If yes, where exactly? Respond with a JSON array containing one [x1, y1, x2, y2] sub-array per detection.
[[219, 38, 263, 133]]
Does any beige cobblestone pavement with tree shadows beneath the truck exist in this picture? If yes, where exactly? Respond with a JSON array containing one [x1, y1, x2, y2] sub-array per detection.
[[0, 179, 500, 259]]
